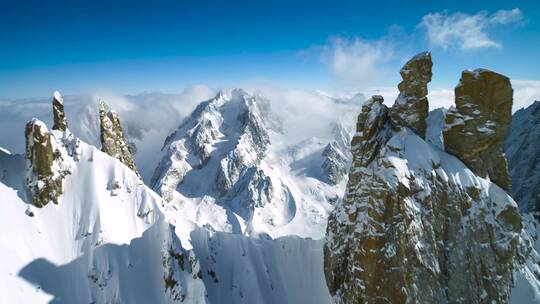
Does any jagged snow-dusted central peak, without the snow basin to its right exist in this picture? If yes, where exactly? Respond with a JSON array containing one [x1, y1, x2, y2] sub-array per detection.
[[153, 89, 296, 234]]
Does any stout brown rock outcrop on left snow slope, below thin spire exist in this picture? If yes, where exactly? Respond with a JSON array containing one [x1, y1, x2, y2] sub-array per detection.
[[24, 118, 63, 208]]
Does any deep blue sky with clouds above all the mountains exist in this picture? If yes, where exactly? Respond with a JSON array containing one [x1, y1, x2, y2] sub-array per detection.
[[0, 0, 540, 98]]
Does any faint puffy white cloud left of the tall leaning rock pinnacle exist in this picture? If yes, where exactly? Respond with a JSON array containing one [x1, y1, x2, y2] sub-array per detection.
[[323, 37, 394, 88]]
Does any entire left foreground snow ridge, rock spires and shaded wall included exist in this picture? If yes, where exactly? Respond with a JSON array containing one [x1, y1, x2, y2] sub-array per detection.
[[0, 94, 342, 303]]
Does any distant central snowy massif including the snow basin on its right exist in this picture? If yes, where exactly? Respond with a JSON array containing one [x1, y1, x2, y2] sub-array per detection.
[[151, 89, 348, 238]]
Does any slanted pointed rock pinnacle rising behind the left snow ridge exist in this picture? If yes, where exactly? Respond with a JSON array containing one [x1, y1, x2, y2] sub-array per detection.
[[99, 101, 140, 177]]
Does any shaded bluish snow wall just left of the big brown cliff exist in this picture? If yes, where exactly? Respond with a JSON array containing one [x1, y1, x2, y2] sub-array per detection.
[[191, 229, 331, 304]]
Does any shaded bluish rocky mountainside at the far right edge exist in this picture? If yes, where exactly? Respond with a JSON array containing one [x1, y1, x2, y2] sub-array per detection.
[[504, 101, 540, 220]]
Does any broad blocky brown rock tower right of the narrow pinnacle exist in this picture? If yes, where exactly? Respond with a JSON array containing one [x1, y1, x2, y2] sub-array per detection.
[[443, 69, 513, 190]]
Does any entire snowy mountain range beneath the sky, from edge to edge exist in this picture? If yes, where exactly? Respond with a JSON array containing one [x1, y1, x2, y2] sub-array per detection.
[[0, 52, 540, 304]]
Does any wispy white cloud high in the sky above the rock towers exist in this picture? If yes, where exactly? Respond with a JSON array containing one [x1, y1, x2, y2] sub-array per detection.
[[418, 8, 523, 50]]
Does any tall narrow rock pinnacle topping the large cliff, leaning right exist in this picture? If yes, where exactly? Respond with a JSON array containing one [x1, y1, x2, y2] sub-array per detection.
[[390, 52, 433, 138]]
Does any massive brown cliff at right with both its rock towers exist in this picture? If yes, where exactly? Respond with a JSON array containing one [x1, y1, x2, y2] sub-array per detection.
[[324, 53, 531, 303]]
